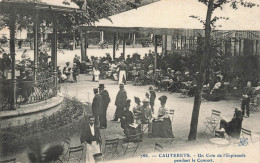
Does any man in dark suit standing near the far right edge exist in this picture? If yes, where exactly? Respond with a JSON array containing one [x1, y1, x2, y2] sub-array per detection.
[[241, 81, 253, 118]]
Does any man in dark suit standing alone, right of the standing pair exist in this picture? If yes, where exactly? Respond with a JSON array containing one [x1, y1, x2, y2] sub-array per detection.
[[113, 83, 127, 121]]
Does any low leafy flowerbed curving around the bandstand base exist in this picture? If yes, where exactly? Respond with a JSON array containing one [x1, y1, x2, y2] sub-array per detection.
[[0, 98, 91, 156]]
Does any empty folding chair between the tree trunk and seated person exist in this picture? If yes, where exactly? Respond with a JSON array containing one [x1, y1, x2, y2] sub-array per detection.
[[204, 110, 221, 135]]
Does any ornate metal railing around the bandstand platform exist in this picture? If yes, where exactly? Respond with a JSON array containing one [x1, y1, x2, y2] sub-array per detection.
[[0, 72, 59, 110]]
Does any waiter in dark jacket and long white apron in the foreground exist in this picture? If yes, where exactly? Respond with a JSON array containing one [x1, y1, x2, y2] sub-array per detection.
[[80, 116, 101, 163]]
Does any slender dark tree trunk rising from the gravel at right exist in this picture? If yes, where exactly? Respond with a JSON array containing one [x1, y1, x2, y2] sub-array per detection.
[[188, 0, 214, 141]]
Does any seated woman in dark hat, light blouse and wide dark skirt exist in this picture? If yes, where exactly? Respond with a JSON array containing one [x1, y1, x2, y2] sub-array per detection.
[[152, 96, 174, 138]]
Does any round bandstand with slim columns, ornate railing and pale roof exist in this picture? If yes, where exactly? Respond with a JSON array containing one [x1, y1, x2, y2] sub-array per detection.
[[0, 0, 81, 122]]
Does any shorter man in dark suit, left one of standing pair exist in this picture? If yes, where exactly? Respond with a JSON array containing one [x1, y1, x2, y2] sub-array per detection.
[[92, 88, 103, 127]]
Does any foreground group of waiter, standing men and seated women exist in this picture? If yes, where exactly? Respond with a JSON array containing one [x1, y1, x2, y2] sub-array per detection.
[[80, 83, 174, 160]]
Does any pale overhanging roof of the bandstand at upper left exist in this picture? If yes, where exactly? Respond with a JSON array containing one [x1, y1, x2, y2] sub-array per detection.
[[0, 0, 79, 12]]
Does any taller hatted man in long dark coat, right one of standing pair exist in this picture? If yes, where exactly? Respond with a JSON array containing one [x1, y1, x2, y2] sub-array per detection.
[[98, 84, 110, 129]]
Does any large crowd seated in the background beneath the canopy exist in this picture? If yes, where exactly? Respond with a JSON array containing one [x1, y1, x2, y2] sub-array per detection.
[[62, 50, 260, 104]]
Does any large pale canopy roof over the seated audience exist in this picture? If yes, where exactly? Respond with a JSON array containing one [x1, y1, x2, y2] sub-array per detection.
[[82, 0, 260, 39]]
